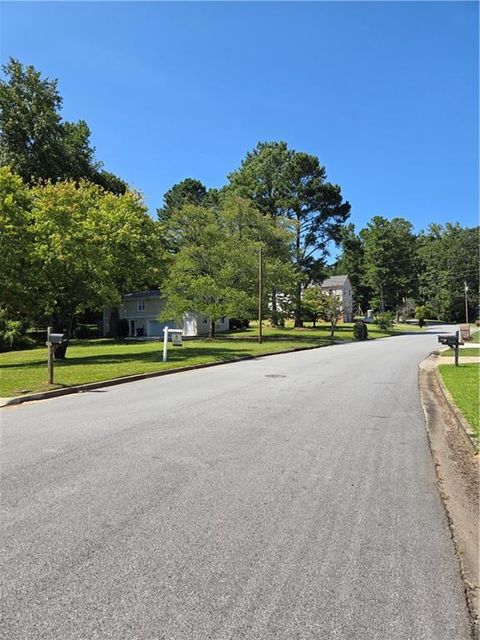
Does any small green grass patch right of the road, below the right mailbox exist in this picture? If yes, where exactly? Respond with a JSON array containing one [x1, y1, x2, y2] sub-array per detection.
[[438, 363, 480, 438]]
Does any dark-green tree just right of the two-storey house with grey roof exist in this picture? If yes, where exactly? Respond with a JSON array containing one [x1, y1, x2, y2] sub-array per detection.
[[360, 216, 417, 312]]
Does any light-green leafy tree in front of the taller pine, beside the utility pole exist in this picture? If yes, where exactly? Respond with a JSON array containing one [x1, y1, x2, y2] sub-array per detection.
[[162, 197, 294, 338]]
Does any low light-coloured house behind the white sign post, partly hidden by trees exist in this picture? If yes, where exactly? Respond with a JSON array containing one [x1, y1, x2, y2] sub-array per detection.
[[103, 289, 230, 338]]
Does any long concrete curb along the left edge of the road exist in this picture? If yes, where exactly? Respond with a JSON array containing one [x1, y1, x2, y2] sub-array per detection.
[[0, 340, 338, 408]]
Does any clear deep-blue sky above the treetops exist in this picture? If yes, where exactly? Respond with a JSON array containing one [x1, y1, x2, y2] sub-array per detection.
[[0, 2, 479, 229]]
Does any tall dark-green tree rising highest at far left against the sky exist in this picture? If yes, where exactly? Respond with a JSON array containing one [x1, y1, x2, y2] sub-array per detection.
[[0, 58, 126, 193]]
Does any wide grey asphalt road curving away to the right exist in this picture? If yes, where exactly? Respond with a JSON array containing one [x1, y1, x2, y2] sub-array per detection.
[[1, 328, 469, 640]]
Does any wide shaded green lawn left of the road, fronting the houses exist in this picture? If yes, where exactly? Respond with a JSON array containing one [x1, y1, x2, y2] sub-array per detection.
[[0, 323, 414, 397]]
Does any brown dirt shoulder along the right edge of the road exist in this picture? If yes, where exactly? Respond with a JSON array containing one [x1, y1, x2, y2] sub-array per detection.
[[419, 356, 480, 638]]
